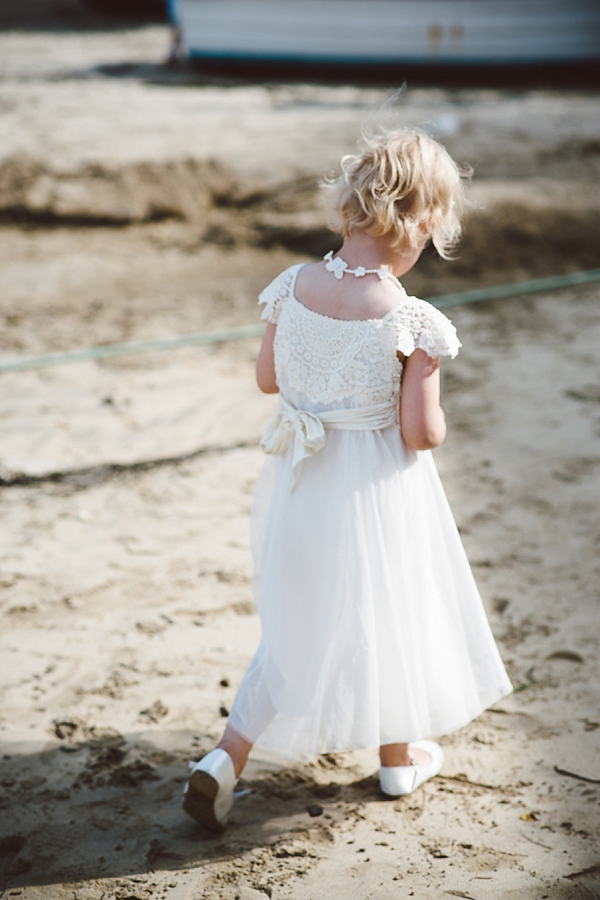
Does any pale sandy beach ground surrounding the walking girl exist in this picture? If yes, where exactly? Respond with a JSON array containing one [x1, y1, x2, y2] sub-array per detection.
[[0, 15, 600, 900]]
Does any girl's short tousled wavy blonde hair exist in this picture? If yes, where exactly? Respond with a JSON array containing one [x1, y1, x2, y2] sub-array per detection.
[[321, 131, 468, 259]]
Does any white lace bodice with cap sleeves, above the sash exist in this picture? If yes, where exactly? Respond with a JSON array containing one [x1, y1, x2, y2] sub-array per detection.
[[258, 264, 460, 406]]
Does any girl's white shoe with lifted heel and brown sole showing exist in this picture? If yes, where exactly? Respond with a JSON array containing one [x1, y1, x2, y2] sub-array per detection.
[[183, 748, 236, 831]]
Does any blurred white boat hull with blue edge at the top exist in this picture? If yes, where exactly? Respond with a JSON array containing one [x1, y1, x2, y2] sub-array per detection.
[[168, 0, 600, 66]]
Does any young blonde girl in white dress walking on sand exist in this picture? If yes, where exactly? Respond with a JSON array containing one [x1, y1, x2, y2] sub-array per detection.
[[184, 126, 511, 830]]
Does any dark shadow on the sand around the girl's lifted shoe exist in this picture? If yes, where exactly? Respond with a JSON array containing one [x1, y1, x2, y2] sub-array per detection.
[[0, 721, 382, 891]]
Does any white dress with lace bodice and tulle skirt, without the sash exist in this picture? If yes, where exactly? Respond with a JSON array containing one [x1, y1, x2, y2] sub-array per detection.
[[229, 265, 511, 759]]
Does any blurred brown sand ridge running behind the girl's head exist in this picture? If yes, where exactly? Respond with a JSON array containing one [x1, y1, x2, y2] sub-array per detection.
[[0, 156, 600, 290]]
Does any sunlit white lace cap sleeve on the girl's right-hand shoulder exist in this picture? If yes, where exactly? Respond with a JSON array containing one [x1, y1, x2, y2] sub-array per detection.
[[393, 297, 462, 359]]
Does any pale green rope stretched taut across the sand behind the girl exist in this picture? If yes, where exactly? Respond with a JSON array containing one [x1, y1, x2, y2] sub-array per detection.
[[0, 269, 600, 372]]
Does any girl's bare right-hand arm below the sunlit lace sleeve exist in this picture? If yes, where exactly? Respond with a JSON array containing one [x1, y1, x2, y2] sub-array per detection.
[[400, 350, 446, 450]]
